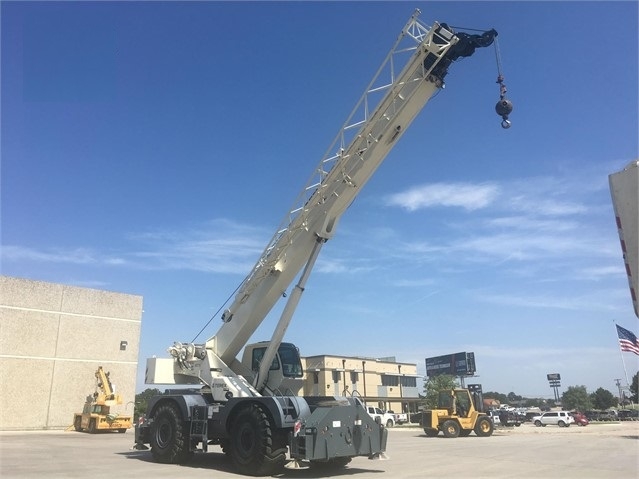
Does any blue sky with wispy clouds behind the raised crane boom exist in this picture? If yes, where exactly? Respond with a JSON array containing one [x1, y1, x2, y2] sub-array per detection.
[[1, 2, 639, 397]]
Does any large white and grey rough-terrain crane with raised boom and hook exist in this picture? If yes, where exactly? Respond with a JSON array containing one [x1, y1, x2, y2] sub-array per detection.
[[136, 10, 504, 475]]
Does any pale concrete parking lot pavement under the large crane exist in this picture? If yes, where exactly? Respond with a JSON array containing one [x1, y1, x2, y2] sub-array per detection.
[[0, 422, 639, 479]]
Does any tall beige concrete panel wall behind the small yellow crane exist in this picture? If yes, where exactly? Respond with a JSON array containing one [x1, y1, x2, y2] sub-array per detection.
[[0, 276, 142, 430]]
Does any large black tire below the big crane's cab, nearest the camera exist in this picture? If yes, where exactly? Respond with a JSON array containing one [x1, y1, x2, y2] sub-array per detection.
[[228, 403, 286, 476]]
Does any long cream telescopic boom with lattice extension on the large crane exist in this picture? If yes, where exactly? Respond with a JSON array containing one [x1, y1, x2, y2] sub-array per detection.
[[211, 15, 498, 364]]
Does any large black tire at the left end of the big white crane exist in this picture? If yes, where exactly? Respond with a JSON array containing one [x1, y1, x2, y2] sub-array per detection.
[[149, 403, 192, 464]]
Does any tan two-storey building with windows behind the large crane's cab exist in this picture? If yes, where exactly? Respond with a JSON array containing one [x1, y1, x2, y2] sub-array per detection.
[[302, 355, 423, 413]]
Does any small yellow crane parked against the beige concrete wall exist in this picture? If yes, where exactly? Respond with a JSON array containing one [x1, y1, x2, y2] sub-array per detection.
[[73, 366, 132, 434]]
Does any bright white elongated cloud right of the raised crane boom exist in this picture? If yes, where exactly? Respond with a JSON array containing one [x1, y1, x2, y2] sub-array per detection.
[[387, 183, 499, 211]]
